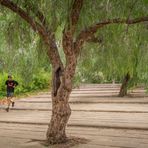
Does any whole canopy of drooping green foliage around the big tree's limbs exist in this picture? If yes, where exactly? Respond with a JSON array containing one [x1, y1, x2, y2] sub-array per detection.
[[0, 0, 148, 92]]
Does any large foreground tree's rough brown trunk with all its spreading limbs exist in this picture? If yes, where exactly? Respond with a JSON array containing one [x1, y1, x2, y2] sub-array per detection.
[[0, 0, 148, 144]]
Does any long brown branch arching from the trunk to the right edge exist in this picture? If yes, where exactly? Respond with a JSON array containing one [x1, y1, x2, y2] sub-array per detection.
[[75, 16, 148, 55]]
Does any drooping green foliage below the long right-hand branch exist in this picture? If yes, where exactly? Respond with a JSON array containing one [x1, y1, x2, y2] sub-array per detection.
[[76, 24, 148, 86]]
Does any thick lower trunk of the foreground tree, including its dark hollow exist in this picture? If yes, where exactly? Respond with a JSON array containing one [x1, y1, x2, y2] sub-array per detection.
[[47, 62, 75, 144]]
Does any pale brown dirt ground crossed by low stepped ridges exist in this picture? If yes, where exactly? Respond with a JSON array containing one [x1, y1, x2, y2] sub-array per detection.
[[0, 84, 148, 148]]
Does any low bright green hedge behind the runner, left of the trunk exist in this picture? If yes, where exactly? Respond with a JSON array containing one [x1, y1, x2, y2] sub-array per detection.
[[0, 71, 51, 98]]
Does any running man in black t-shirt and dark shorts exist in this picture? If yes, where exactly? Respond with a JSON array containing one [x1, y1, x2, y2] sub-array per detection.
[[5, 75, 18, 112]]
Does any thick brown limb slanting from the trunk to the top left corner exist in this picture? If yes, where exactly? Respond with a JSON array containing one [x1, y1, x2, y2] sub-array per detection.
[[0, 0, 62, 67]]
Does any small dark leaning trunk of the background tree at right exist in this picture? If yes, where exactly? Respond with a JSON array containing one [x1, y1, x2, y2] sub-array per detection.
[[119, 73, 130, 97]]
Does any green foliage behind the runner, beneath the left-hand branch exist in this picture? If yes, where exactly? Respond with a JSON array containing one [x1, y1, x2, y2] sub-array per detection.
[[0, 12, 51, 96]]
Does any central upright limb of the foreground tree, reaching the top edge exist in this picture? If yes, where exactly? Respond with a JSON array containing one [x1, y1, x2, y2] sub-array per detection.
[[62, 0, 83, 83]]
